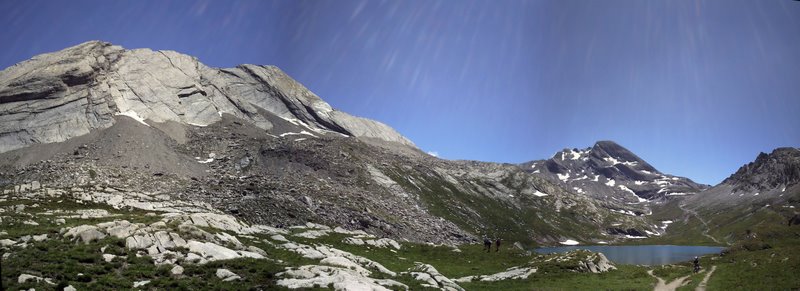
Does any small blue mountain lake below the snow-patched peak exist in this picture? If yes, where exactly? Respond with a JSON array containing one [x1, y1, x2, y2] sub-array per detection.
[[535, 245, 725, 265]]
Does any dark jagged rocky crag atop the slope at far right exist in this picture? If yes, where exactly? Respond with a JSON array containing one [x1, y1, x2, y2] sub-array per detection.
[[722, 148, 800, 192]]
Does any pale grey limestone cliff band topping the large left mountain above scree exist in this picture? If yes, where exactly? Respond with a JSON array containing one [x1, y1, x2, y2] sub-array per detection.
[[0, 41, 414, 152]]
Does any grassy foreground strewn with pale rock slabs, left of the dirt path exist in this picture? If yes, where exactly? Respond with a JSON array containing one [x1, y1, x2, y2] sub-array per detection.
[[0, 177, 615, 290]]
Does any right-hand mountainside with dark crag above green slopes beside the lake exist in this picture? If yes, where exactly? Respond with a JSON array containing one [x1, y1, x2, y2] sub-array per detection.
[[675, 148, 800, 243]]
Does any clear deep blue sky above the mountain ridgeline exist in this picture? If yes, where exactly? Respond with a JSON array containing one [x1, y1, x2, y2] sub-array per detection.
[[0, 0, 800, 184]]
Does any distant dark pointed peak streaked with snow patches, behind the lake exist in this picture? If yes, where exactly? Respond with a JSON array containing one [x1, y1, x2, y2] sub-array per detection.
[[521, 141, 707, 204]]
